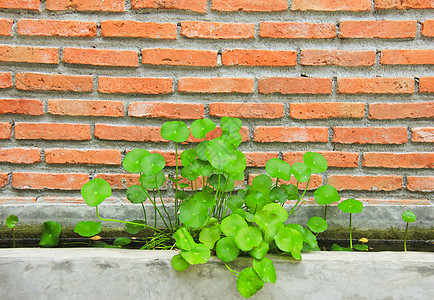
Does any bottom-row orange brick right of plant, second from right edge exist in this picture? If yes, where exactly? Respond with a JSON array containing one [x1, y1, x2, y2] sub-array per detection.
[[327, 175, 402, 191]]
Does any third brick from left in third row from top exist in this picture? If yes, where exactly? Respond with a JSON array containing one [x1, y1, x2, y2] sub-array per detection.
[[142, 48, 217, 67]]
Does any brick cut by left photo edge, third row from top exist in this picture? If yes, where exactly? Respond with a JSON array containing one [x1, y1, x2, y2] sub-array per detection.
[[0, 45, 59, 64]]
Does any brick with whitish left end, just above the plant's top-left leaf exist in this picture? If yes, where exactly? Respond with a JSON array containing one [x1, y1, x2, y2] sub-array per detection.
[[128, 102, 205, 119]]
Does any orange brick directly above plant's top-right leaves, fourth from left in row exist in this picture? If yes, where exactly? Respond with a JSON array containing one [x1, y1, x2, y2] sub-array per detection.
[[209, 102, 284, 119]]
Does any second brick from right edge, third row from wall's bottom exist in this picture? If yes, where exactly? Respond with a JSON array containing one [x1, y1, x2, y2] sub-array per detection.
[[332, 127, 407, 144]]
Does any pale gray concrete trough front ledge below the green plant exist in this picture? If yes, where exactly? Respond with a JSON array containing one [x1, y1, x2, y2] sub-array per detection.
[[0, 249, 434, 300]]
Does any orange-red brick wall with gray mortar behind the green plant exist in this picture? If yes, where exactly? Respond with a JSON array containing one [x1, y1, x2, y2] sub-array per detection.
[[0, 0, 434, 211]]
